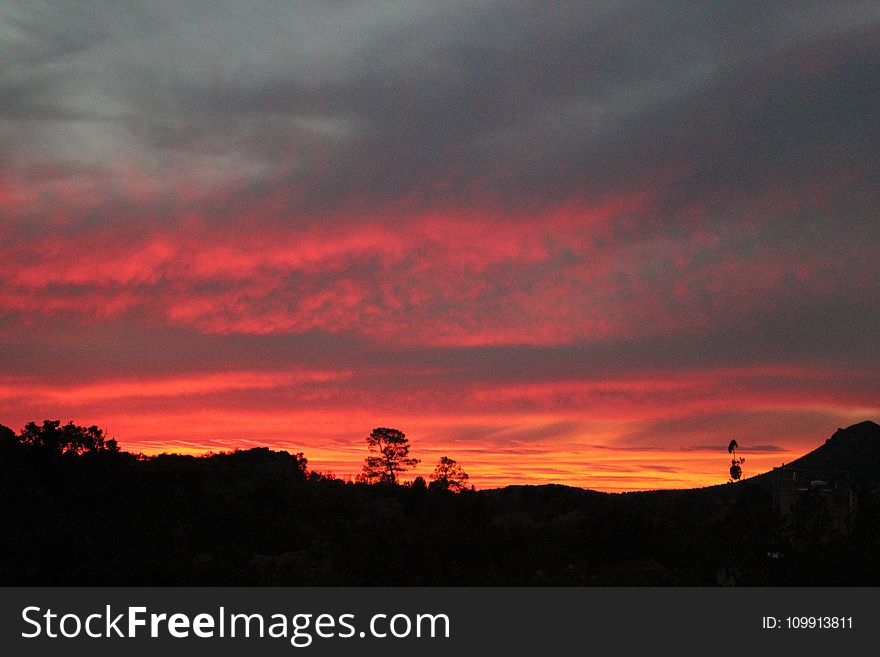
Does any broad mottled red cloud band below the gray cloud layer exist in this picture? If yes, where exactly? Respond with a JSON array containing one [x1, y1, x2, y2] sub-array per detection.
[[0, 184, 878, 345]]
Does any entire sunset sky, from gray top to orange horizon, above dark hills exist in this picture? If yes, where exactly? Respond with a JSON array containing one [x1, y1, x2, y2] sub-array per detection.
[[0, 0, 880, 491]]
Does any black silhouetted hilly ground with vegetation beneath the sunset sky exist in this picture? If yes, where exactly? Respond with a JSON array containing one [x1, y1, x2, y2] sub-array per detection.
[[0, 422, 880, 586]]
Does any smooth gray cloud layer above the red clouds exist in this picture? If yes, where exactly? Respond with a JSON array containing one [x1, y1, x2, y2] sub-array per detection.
[[0, 2, 880, 210]]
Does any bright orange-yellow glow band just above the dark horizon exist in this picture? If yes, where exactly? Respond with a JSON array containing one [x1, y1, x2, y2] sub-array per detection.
[[0, 367, 880, 492]]
